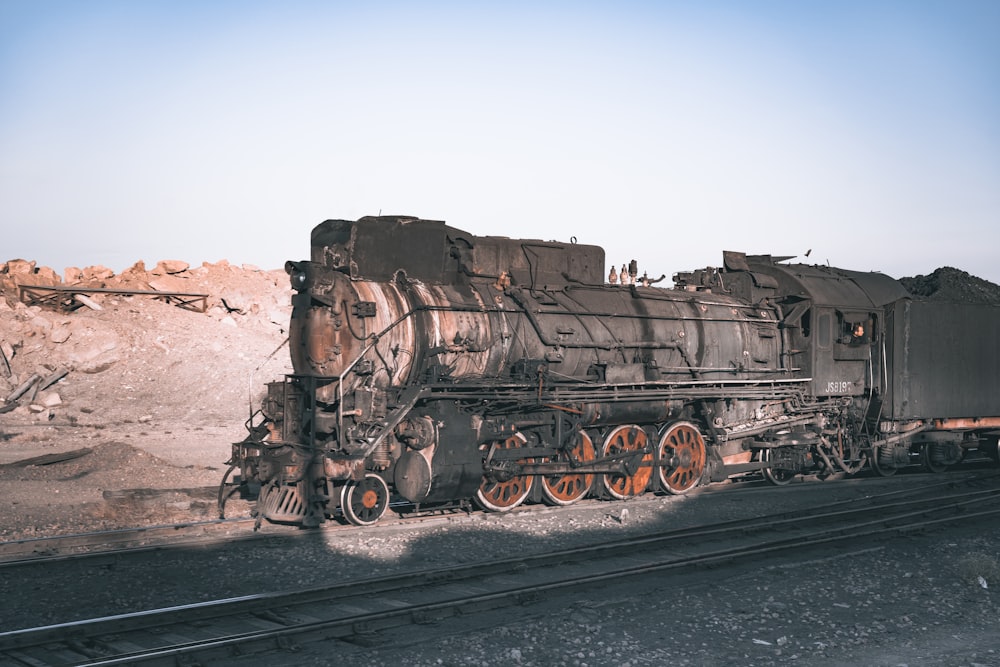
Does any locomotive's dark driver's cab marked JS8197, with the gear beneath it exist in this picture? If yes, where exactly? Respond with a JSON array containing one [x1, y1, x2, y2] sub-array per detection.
[[700, 252, 906, 483]]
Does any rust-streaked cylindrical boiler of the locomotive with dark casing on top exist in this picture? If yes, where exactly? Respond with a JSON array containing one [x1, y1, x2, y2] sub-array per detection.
[[288, 221, 785, 384]]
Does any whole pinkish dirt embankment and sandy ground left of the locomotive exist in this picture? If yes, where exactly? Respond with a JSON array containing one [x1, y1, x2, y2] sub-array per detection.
[[0, 260, 291, 540]]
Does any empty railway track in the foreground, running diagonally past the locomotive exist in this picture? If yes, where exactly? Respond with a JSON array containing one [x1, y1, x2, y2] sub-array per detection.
[[0, 475, 1000, 665]]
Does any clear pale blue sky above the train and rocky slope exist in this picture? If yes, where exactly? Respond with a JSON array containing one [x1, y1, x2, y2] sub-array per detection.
[[0, 0, 1000, 282]]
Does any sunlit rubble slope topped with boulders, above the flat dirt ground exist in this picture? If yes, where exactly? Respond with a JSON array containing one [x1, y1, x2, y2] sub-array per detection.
[[0, 259, 291, 423]]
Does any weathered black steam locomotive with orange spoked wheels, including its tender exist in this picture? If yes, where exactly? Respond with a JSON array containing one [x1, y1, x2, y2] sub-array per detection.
[[220, 216, 1000, 526]]
